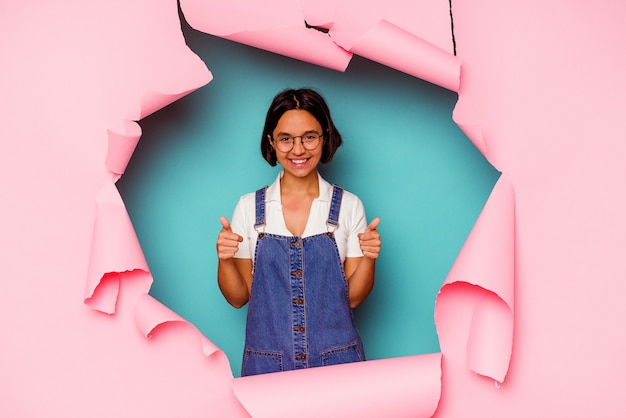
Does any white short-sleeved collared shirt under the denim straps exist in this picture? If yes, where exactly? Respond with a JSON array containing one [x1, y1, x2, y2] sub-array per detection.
[[230, 171, 367, 262]]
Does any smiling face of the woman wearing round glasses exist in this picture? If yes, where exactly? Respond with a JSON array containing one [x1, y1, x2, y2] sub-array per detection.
[[271, 109, 324, 177]]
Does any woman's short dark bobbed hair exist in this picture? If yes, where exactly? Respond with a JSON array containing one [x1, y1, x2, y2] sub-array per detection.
[[261, 88, 342, 167]]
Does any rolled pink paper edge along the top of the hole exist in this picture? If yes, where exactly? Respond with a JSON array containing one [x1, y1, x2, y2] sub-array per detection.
[[181, 1, 460, 92]]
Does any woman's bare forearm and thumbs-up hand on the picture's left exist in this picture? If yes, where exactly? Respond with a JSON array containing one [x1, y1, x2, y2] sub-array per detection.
[[216, 217, 252, 308]]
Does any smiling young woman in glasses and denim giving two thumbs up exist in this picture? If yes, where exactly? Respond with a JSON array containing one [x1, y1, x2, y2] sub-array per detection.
[[216, 89, 381, 376]]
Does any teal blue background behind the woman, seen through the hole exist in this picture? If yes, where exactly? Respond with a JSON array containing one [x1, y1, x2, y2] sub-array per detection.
[[117, 22, 499, 376]]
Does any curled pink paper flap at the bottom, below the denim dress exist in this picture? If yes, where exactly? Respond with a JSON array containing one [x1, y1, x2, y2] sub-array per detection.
[[233, 353, 442, 418]]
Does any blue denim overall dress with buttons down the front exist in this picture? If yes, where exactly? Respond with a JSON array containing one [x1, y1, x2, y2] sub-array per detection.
[[241, 186, 365, 376]]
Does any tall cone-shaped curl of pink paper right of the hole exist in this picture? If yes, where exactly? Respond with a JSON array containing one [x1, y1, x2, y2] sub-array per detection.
[[435, 175, 515, 383]]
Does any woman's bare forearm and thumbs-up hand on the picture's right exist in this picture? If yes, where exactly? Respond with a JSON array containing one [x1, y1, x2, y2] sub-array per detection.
[[344, 218, 381, 308]]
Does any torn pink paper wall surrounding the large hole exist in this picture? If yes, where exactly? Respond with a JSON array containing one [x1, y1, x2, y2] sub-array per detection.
[[0, 0, 626, 417]]
